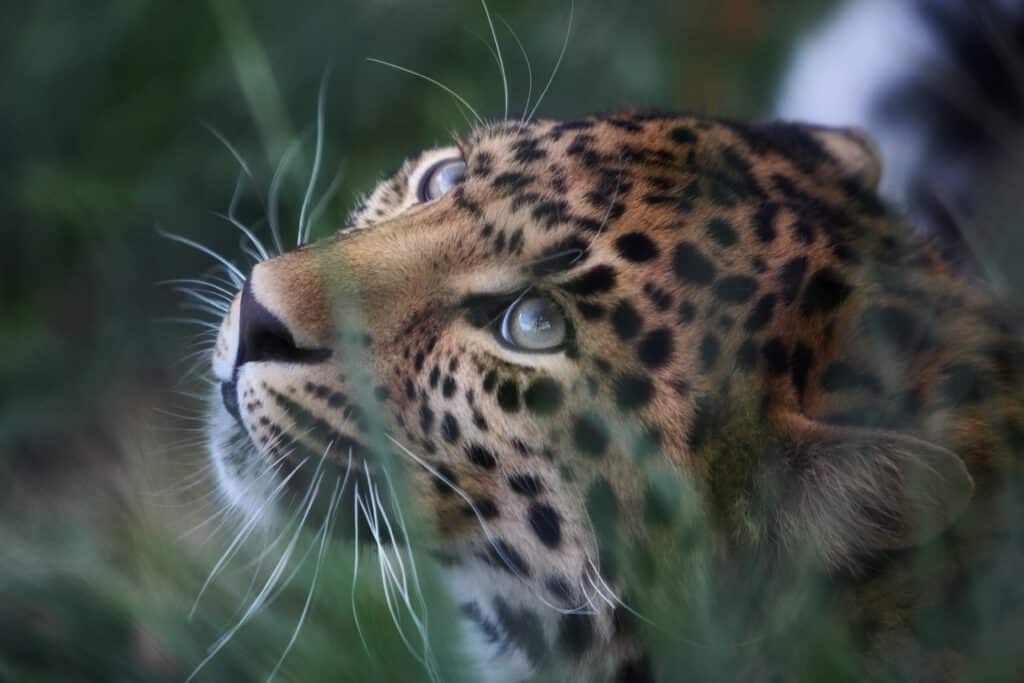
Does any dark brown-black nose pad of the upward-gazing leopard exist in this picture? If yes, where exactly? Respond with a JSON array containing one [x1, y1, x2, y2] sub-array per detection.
[[234, 279, 331, 369]]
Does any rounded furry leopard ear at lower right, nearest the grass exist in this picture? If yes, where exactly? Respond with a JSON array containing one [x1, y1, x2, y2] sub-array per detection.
[[779, 416, 974, 567]]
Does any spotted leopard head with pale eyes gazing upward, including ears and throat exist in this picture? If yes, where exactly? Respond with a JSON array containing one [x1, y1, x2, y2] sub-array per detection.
[[203, 114, 1019, 680]]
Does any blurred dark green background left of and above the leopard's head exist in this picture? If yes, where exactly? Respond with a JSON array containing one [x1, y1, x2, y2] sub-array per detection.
[[0, 0, 864, 681]]
